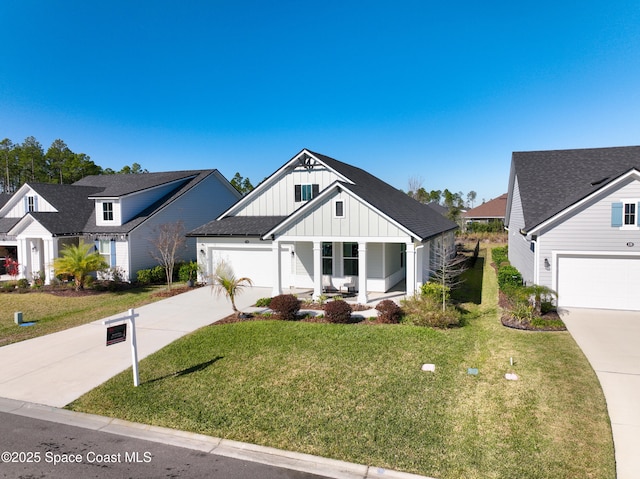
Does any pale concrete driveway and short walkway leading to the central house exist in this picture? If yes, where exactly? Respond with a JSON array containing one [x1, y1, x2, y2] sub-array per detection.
[[0, 287, 271, 407]]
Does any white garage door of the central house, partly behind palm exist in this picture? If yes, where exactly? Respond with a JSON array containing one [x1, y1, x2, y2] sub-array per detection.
[[210, 248, 274, 287]]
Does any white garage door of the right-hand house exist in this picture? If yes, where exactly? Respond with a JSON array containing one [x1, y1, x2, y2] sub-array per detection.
[[558, 256, 640, 310]]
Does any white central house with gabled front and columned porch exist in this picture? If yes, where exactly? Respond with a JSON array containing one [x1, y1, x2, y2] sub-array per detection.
[[188, 149, 457, 303]]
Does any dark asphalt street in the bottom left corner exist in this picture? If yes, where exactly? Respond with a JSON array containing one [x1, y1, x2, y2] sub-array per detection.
[[0, 413, 325, 479]]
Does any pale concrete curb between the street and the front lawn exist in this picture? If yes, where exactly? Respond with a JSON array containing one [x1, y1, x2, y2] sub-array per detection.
[[0, 398, 433, 479]]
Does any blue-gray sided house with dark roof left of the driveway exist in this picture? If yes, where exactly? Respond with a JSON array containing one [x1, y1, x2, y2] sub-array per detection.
[[0, 170, 241, 283]]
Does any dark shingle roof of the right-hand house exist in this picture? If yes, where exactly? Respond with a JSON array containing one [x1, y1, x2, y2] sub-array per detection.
[[510, 146, 640, 231]]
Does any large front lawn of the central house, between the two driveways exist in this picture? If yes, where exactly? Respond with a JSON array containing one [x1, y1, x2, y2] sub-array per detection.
[[68, 251, 615, 479]]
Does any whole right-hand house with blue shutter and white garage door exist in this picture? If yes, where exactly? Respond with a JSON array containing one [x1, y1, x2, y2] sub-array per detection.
[[506, 146, 640, 310]]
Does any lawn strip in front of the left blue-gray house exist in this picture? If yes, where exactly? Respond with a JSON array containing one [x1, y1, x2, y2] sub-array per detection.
[[0, 286, 166, 346]]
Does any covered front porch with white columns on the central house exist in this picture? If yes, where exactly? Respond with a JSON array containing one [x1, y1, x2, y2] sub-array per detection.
[[272, 238, 429, 304]]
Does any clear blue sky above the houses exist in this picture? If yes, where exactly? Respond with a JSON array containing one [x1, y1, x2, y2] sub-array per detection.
[[0, 0, 640, 204]]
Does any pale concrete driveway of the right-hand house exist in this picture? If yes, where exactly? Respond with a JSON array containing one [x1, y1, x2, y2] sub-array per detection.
[[562, 308, 640, 479]]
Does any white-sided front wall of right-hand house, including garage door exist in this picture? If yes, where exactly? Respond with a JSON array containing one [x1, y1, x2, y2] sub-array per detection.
[[537, 179, 640, 310]]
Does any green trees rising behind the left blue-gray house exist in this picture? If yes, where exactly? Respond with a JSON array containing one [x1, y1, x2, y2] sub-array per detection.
[[0, 136, 148, 193]]
